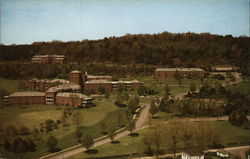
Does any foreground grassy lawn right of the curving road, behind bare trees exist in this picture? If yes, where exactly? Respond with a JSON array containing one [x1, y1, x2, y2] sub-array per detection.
[[70, 121, 250, 159]]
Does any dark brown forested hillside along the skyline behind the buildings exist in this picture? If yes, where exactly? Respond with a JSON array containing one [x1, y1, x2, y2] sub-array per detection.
[[0, 32, 250, 77]]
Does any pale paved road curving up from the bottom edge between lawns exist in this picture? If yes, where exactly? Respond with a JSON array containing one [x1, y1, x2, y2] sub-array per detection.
[[43, 103, 150, 159]]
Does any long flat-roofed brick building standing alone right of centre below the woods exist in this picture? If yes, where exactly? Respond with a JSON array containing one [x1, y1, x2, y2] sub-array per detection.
[[154, 68, 205, 79]]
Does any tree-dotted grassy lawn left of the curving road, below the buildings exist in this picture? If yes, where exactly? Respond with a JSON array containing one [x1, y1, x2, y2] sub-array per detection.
[[0, 99, 127, 159]]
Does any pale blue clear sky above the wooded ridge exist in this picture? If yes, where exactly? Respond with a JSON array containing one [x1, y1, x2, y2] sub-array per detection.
[[0, 0, 250, 45]]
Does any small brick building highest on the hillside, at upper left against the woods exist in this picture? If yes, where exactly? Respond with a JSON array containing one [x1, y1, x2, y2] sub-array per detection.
[[31, 55, 65, 64]]
